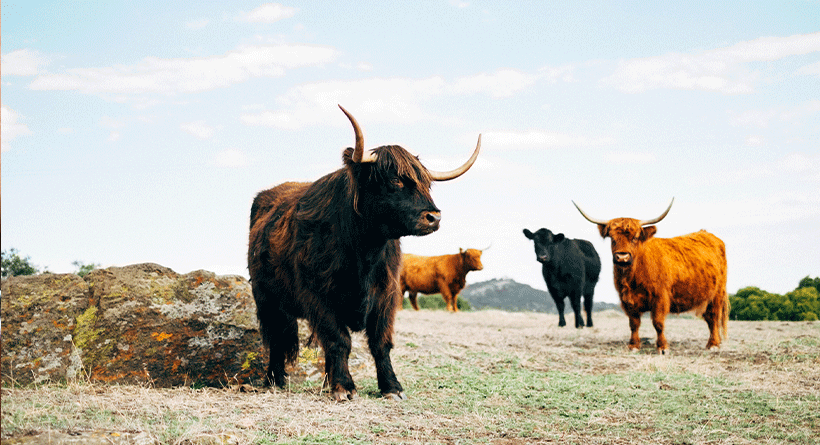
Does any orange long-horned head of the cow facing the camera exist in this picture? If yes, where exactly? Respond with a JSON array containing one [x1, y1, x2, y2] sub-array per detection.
[[573, 198, 675, 267]]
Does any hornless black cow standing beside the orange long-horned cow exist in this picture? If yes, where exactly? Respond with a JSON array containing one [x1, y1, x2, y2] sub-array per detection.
[[524, 229, 601, 328]]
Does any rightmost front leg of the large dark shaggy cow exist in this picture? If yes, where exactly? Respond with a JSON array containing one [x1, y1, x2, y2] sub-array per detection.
[[366, 294, 407, 400]]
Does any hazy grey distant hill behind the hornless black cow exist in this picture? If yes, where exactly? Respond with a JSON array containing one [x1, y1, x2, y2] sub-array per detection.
[[460, 278, 620, 314]]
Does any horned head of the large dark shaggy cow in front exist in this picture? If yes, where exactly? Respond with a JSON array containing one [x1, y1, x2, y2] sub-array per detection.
[[339, 105, 481, 239]]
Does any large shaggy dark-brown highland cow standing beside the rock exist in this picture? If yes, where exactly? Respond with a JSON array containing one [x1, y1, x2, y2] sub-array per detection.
[[248, 106, 481, 401]]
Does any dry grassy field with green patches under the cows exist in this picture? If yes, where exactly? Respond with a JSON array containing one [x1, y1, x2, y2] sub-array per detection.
[[2, 310, 820, 444]]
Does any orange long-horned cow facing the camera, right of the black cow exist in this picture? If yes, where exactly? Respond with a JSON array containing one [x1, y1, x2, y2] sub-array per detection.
[[573, 198, 729, 354]]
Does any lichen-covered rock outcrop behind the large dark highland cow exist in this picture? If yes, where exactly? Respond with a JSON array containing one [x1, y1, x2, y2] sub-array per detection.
[[2, 263, 272, 387]]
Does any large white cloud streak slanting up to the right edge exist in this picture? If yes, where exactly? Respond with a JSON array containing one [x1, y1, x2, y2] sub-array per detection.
[[602, 33, 820, 94]]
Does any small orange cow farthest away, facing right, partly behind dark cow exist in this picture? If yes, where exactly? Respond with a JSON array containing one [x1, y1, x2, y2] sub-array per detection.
[[401, 249, 486, 312]]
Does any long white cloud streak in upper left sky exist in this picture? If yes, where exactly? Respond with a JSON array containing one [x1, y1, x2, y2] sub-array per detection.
[[28, 44, 338, 101]]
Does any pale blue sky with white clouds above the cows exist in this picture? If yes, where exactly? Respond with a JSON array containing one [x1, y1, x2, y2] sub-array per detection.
[[0, 0, 820, 303]]
